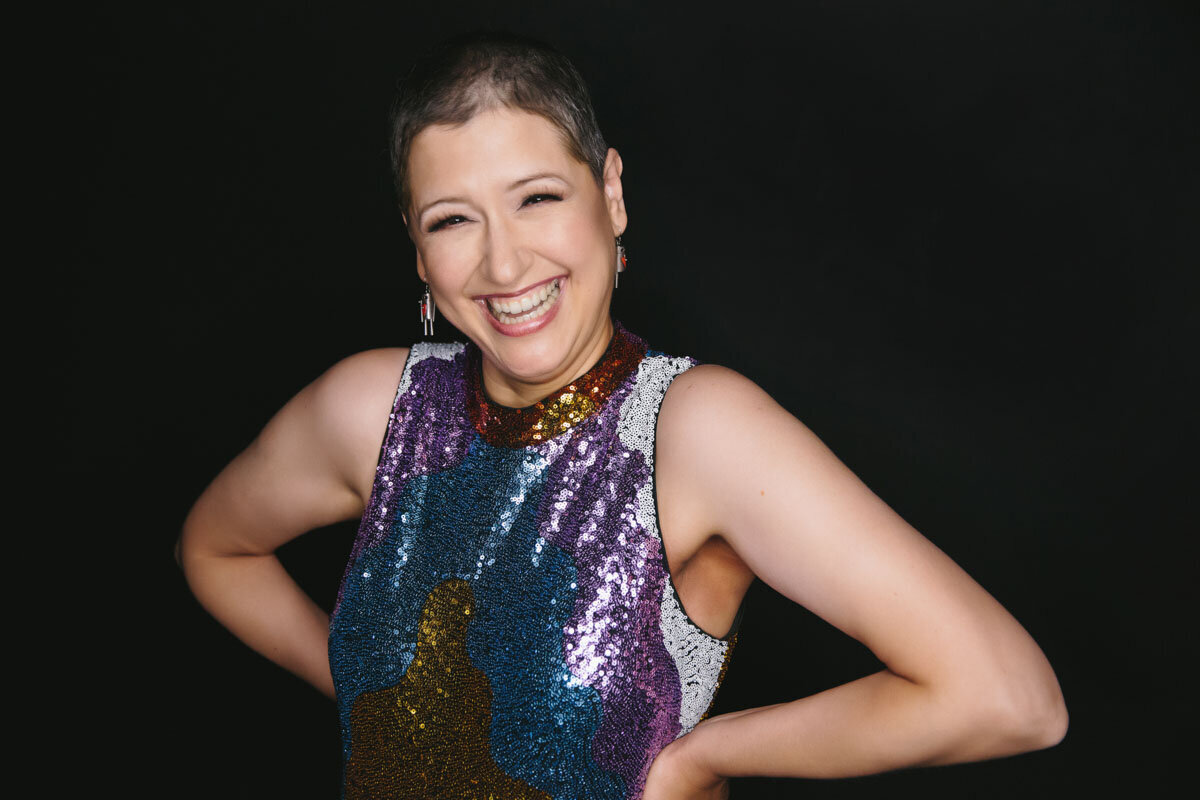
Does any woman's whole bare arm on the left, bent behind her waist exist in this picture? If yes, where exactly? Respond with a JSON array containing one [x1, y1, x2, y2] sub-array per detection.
[[175, 348, 408, 698]]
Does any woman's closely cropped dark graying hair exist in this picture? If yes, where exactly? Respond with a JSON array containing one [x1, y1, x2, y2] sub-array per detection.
[[391, 31, 608, 219]]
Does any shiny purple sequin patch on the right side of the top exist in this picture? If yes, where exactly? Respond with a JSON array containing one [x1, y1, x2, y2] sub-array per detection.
[[539, 375, 680, 796]]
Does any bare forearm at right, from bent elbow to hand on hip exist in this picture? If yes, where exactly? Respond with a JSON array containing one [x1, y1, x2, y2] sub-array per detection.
[[677, 670, 1066, 778]]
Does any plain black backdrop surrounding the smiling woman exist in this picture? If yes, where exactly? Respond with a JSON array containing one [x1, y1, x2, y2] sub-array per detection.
[[70, 1, 1200, 798]]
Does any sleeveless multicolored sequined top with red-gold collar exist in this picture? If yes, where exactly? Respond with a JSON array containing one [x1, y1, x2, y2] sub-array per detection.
[[329, 324, 737, 800]]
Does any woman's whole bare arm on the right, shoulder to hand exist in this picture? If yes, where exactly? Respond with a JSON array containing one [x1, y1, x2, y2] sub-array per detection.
[[646, 366, 1067, 800]]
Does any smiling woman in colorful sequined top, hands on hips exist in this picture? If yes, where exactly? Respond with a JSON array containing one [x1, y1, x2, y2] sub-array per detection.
[[179, 36, 1067, 800]]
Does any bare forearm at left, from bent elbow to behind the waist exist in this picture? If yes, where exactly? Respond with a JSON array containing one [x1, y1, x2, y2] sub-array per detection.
[[179, 548, 334, 698]]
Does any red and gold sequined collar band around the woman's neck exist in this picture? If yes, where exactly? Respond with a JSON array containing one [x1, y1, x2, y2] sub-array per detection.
[[466, 320, 647, 447]]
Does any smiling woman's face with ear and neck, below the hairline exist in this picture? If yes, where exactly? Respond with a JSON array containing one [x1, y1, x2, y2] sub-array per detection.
[[406, 107, 626, 405]]
